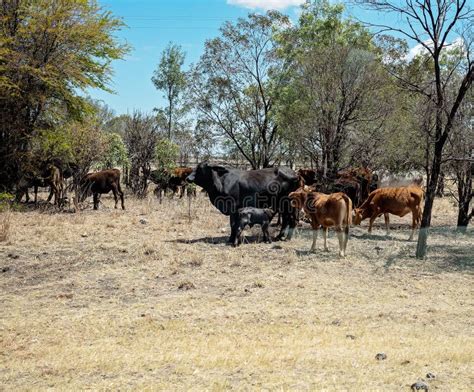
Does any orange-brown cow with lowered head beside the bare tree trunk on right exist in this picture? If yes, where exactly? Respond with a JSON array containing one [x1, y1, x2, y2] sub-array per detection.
[[354, 186, 423, 241]]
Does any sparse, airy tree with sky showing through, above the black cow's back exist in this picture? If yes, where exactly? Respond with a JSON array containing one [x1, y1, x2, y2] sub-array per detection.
[[190, 12, 289, 169]]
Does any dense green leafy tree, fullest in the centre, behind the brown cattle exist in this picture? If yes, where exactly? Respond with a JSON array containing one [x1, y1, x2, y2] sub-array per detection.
[[279, 1, 392, 177]]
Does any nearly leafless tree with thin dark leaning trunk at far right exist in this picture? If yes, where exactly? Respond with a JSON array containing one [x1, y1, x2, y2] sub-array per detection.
[[362, 0, 474, 258]]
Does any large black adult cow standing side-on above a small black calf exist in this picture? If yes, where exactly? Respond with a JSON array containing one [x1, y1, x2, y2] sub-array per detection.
[[187, 163, 300, 244]]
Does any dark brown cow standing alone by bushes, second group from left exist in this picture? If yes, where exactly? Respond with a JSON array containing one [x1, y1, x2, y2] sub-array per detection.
[[80, 169, 125, 210]]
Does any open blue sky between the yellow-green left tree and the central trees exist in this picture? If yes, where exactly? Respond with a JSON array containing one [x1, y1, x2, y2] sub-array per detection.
[[88, 0, 400, 114]]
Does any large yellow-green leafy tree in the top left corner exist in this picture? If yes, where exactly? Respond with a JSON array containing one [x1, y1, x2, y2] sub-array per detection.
[[0, 0, 127, 188]]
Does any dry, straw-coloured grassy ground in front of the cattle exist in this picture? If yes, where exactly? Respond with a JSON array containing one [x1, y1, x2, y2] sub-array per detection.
[[0, 191, 474, 391]]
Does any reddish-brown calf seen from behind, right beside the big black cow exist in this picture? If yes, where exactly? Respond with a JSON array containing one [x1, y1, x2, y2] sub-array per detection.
[[290, 187, 352, 257]]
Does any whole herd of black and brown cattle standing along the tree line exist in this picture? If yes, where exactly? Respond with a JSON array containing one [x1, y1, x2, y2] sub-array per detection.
[[16, 163, 424, 257]]
